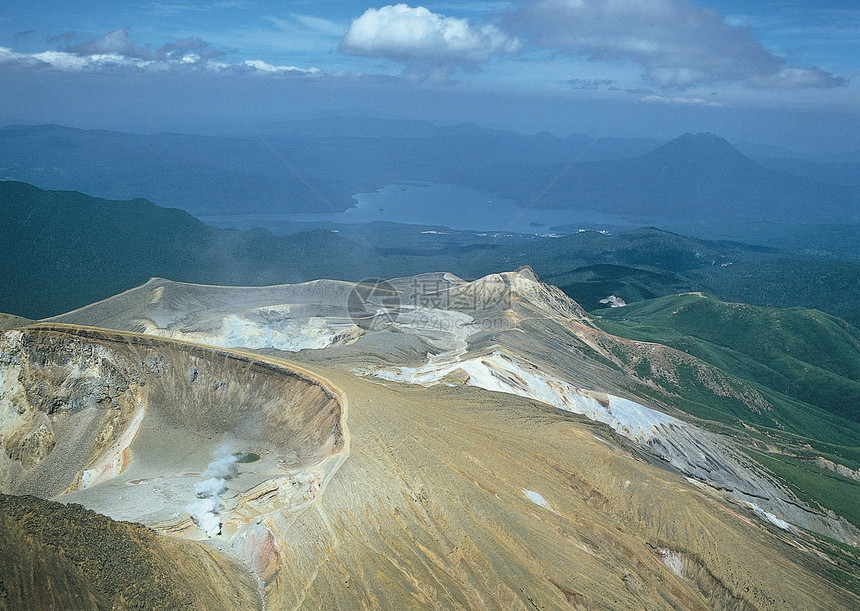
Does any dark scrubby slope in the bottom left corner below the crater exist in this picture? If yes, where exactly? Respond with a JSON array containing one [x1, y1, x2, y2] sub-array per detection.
[[0, 494, 257, 611]]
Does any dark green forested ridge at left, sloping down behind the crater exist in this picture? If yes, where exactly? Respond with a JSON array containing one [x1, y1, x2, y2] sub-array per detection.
[[0, 182, 384, 318]]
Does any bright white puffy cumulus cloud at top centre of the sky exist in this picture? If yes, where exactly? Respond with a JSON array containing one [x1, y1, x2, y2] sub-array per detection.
[[339, 4, 523, 67]]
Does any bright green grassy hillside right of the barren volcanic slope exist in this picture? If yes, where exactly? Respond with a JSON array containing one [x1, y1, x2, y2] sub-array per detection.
[[597, 294, 860, 527]]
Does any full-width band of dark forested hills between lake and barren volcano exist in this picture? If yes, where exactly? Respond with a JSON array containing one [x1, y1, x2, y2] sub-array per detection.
[[0, 182, 860, 325]]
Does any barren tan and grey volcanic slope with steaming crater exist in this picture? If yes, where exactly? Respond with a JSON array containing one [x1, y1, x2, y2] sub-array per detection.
[[0, 270, 860, 609]]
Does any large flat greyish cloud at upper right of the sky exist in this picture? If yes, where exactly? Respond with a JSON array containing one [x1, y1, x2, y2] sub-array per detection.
[[508, 0, 845, 89]]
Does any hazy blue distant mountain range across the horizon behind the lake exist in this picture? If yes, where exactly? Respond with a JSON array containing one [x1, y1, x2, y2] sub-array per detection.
[[0, 120, 860, 224]]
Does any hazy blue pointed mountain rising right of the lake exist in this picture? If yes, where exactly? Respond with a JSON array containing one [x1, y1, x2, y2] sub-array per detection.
[[524, 134, 860, 223]]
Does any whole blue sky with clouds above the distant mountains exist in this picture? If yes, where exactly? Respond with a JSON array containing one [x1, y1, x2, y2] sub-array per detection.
[[0, 0, 860, 150]]
